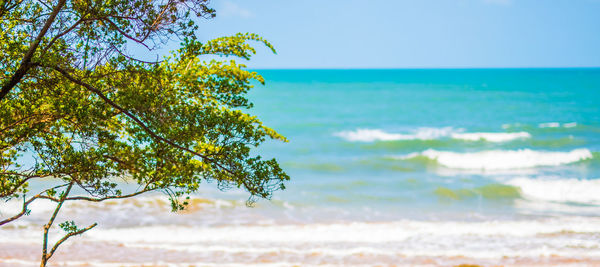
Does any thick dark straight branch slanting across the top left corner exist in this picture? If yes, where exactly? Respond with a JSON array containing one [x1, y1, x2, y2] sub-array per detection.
[[0, 0, 67, 101]]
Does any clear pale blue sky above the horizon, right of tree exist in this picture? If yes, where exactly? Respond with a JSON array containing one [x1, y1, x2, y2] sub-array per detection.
[[193, 0, 600, 68]]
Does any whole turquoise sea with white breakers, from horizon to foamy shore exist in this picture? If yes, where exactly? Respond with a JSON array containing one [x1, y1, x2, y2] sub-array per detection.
[[0, 68, 600, 267]]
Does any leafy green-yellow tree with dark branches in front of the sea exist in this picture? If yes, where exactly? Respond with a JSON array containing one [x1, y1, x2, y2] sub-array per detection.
[[0, 0, 289, 266]]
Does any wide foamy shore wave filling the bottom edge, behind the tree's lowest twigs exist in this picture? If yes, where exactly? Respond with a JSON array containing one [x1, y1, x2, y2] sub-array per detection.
[[0, 217, 600, 266]]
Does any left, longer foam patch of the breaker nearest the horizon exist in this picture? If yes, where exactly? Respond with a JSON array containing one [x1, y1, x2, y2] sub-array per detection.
[[333, 127, 457, 142]]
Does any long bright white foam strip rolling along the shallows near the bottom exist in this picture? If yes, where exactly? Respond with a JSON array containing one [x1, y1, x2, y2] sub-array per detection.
[[86, 217, 600, 245]]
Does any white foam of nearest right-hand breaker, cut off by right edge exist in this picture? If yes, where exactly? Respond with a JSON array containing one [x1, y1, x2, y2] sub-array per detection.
[[507, 178, 600, 205]]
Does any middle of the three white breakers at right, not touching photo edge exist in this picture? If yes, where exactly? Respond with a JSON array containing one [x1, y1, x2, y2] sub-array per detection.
[[396, 148, 593, 170]]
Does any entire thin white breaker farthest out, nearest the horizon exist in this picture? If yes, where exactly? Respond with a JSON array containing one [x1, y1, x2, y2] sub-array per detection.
[[334, 127, 531, 142]]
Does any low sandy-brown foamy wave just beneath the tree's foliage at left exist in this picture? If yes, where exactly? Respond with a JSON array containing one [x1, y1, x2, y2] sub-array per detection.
[[0, 193, 253, 228]]
